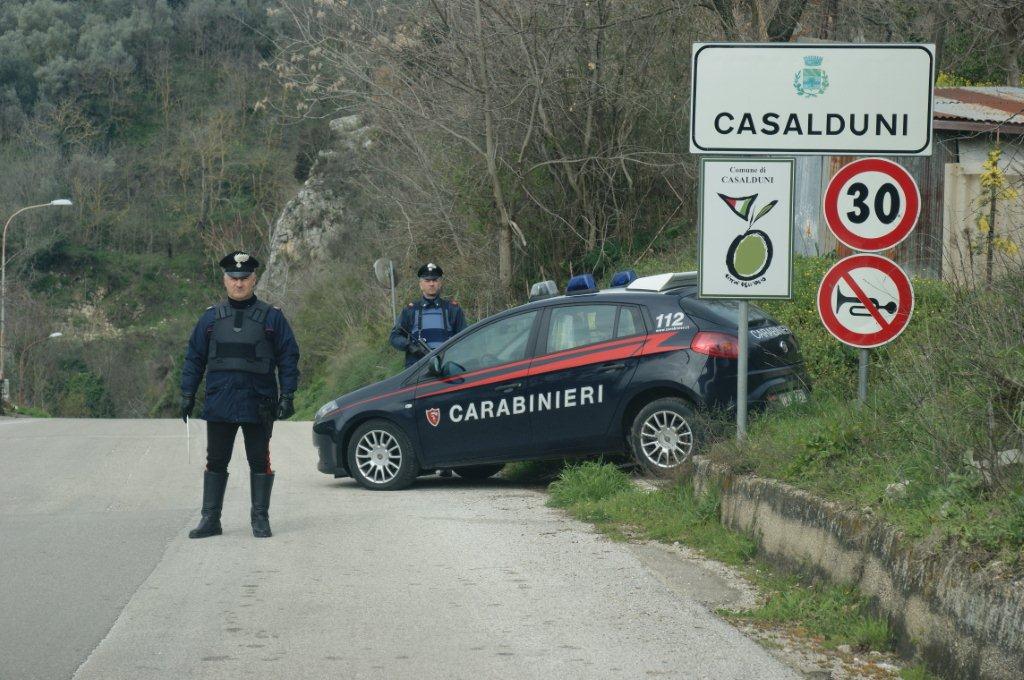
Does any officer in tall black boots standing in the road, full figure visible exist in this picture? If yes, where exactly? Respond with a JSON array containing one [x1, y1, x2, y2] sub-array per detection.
[[181, 251, 299, 539]]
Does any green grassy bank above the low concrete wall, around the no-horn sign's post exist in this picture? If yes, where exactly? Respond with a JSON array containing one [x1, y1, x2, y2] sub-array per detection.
[[706, 258, 1024, 573]]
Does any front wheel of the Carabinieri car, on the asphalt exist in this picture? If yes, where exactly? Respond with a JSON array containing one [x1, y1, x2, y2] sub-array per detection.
[[346, 419, 420, 492]]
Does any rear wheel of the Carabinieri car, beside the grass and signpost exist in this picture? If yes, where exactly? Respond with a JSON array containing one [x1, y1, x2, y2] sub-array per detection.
[[629, 396, 700, 474]]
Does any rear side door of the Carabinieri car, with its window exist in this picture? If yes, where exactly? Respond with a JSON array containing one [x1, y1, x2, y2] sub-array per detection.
[[530, 302, 646, 453]]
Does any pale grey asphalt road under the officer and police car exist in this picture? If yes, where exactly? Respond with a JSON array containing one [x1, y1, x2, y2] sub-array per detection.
[[0, 419, 798, 680]]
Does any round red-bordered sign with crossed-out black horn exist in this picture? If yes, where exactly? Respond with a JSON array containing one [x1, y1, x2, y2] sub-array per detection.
[[818, 254, 913, 349]]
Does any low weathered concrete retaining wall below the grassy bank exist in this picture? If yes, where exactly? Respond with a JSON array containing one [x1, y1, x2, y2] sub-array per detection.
[[693, 459, 1024, 680]]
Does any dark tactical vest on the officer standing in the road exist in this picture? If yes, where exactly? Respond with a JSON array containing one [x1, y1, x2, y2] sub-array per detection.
[[206, 300, 273, 374]]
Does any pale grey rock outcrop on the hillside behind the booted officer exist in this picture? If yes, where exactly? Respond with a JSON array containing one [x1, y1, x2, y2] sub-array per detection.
[[257, 116, 374, 300]]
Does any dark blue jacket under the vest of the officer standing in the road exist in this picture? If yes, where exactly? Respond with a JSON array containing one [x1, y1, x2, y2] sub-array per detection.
[[181, 296, 299, 423]]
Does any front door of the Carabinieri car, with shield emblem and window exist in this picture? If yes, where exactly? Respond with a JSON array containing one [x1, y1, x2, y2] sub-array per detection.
[[414, 309, 541, 467]]
